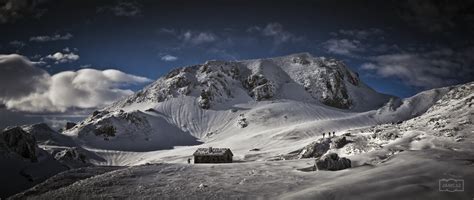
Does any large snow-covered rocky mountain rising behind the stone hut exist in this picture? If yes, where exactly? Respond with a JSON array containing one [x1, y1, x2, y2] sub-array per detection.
[[64, 53, 395, 151]]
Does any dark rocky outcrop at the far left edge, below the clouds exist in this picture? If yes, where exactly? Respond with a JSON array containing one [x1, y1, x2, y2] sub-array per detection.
[[2, 126, 37, 162]]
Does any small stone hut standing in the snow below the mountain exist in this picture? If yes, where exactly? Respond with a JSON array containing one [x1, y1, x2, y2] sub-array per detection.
[[193, 147, 234, 163]]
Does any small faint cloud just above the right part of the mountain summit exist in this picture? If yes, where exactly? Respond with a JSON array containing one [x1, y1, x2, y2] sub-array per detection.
[[323, 39, 365, 56]]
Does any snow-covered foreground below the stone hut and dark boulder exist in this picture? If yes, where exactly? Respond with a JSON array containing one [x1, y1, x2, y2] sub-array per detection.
[[11, 144, 474, 199]]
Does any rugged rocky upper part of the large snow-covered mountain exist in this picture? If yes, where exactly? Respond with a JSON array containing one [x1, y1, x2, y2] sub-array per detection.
[[107, 52, 388, 110]]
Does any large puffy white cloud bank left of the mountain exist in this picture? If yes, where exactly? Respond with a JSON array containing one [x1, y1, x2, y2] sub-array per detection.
[[0, 55, 151, 112]]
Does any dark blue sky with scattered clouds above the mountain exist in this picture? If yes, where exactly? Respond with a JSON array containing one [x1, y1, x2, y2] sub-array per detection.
[[0, 0, 474, 97]]
